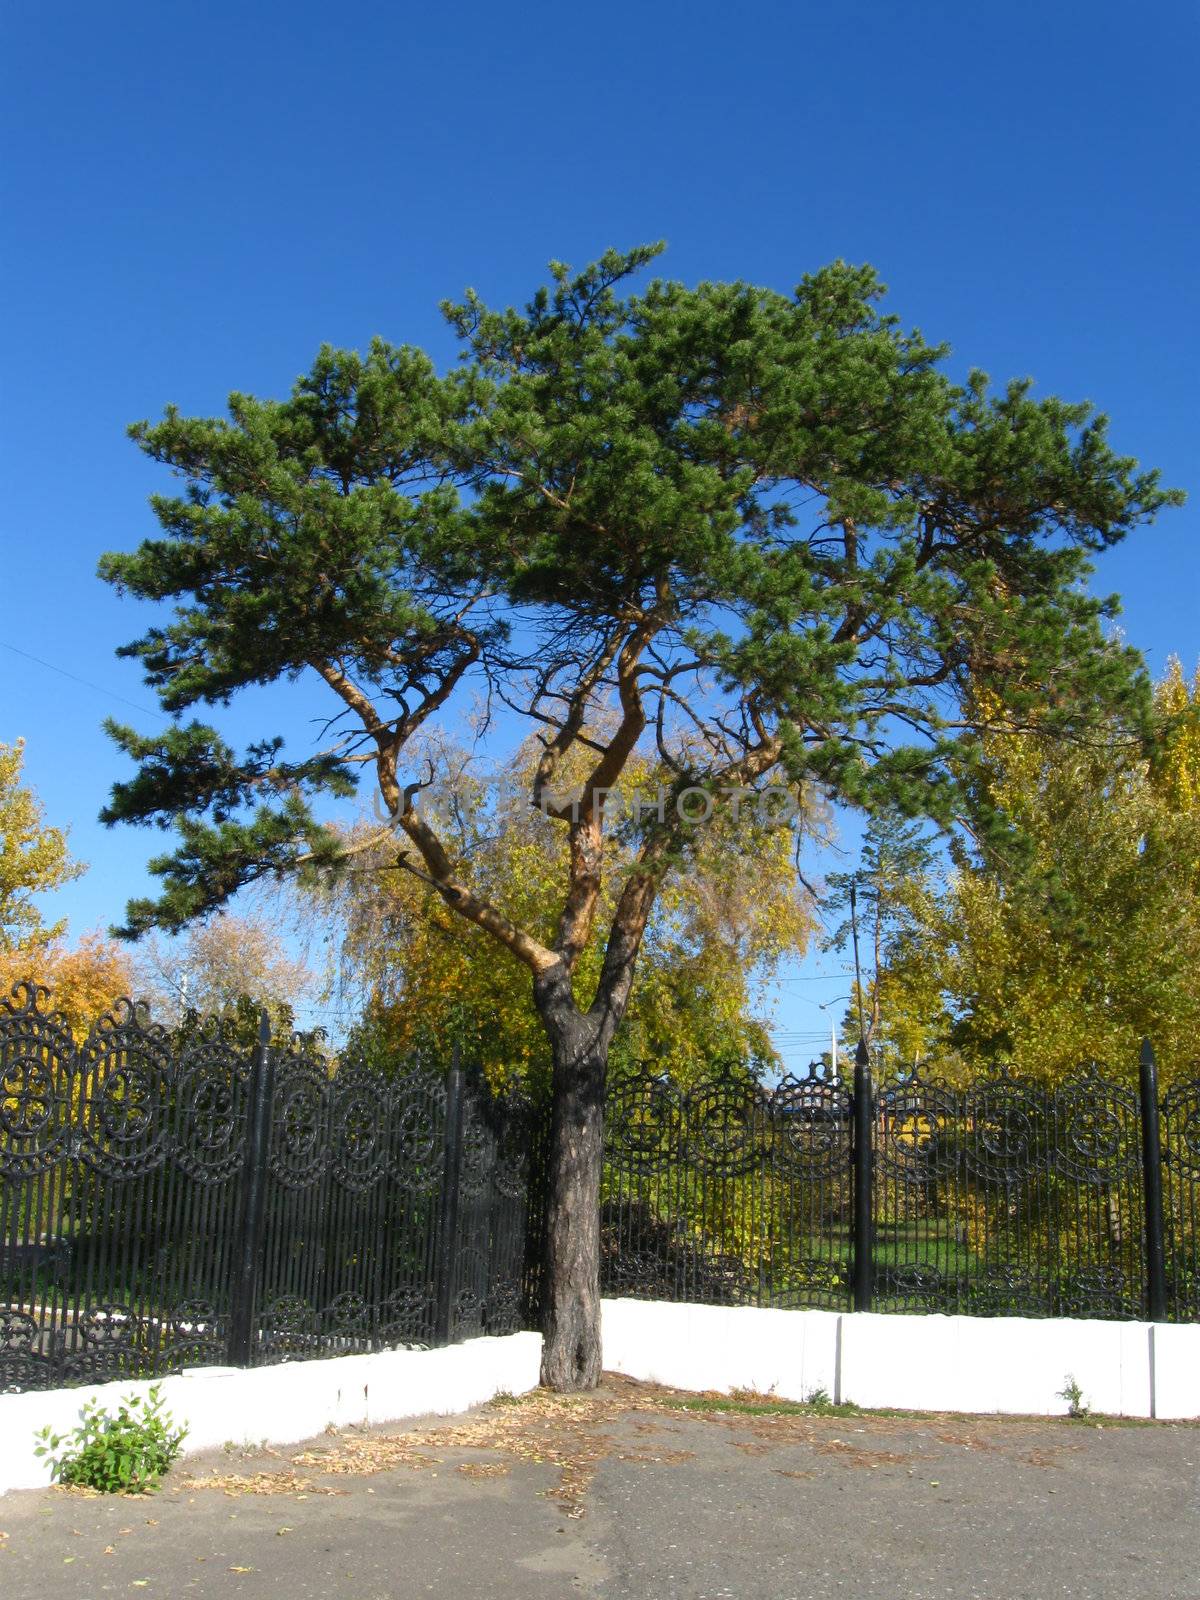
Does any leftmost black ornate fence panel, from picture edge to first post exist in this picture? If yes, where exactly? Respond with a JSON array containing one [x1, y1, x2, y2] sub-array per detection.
[[0, 986, 246, 1390]]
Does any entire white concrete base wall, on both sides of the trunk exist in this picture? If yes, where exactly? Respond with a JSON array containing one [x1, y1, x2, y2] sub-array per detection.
[[0, 1299, 1200, 1494]]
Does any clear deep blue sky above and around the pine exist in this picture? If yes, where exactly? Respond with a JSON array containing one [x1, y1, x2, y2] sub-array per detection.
[[0, 0, 1200, 1054]]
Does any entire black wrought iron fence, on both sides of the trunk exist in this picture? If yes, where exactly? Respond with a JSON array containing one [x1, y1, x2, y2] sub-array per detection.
[[9, 966, 1200, 1390]]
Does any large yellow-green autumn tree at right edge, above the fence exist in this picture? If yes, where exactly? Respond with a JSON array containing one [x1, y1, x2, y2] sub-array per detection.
[[878, 662, 1200, 1082]]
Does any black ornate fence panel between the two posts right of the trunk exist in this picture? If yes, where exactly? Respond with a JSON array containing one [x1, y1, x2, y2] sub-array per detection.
[[870, 1069, 1146, 1318]]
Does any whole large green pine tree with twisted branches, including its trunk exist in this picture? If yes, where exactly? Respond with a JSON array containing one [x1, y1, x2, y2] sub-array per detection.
[[101, 248, 1173, 1389]]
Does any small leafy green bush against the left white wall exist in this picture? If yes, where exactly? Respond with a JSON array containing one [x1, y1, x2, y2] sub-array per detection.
[[35, 1384, 187, 1494]]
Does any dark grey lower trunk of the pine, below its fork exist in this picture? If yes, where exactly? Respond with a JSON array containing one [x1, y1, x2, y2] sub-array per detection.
[[538, 989, 608, 1392]]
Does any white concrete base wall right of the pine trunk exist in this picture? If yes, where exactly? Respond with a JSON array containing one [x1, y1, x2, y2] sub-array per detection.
[[603, 1299, 1200, 1418]]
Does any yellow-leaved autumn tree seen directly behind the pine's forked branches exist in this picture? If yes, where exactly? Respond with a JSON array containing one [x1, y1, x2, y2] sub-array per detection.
[[320, 741, 821, 1093]]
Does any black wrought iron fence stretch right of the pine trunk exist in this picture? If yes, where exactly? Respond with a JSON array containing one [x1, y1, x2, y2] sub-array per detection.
[[600, 1043, 1200, 1322]]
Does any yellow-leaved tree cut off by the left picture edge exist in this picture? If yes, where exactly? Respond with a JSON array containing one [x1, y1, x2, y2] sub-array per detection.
[[0, 739, 86, 965]]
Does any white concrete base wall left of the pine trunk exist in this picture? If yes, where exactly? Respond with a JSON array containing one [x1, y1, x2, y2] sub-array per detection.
[[0, 1333, 542, 1494]]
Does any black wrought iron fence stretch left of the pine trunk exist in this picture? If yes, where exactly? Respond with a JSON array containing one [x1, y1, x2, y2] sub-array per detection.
[[0, 986, 530, 1390]]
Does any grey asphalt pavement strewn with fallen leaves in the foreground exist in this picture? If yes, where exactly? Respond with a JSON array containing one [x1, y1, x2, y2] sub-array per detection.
[[0, 1381, 1200, 1600]]
